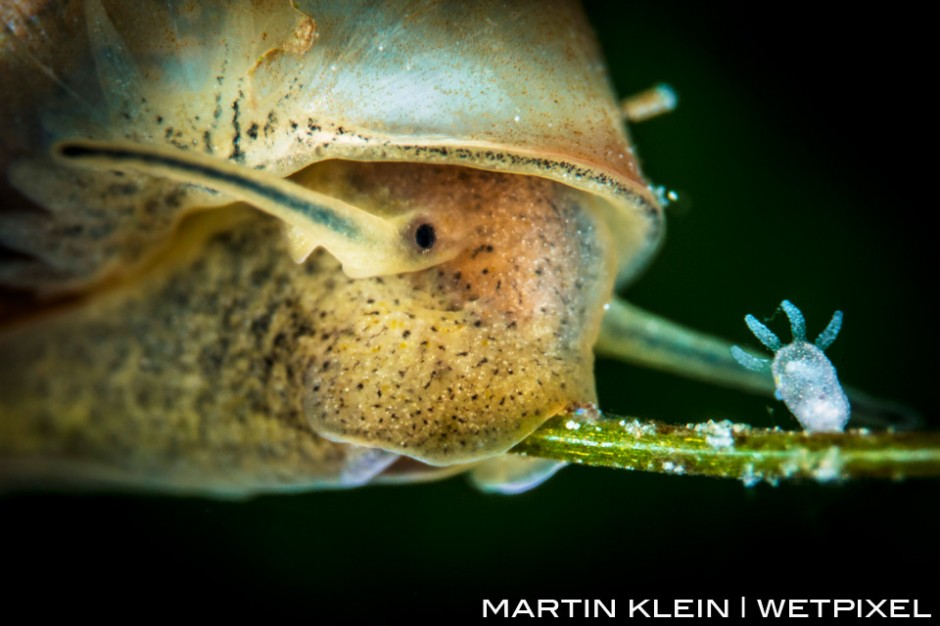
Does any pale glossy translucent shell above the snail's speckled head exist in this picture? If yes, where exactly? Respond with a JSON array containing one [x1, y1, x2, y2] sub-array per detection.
[[0, 0, 662, 291]]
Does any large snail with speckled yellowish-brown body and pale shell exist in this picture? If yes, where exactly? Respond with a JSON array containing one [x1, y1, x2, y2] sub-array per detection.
[[0, 0, 662, 495]]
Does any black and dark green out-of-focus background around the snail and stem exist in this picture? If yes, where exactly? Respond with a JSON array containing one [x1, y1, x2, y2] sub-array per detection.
[[0, 1, 940, 623]]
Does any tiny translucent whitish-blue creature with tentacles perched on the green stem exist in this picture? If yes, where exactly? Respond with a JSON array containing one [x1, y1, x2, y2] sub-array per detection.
[[731, 300, 849, 432]]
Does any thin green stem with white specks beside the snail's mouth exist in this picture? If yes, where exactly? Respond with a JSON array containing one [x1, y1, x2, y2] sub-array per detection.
[[511, 408, 940, 485]]
